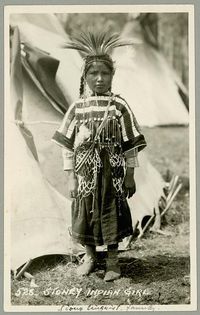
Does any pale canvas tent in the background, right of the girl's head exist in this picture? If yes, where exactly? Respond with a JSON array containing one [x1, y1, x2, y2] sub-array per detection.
[[113, 14, 189, 127]]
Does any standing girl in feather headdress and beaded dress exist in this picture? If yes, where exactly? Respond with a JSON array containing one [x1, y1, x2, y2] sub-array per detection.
[[53, 33, 146, 281]]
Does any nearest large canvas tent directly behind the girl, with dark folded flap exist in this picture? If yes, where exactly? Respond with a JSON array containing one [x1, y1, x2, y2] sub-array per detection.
[[5, 14, 184, 276]]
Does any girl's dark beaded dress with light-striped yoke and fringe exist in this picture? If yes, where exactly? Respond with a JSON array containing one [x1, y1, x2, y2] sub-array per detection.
[[53, 93, 146, 246]]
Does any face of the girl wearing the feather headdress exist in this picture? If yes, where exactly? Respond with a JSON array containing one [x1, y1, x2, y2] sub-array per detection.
[[86, 61, 113, 94]]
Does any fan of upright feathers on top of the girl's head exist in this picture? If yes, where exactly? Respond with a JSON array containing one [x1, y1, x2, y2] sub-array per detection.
[[63, 31, 134, 59]]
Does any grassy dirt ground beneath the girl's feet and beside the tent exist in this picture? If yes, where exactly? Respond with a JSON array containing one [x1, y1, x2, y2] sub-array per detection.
[[11, 127, 190, 306]]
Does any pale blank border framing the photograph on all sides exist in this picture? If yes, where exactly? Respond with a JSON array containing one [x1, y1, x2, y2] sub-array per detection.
[[4, 4, 197, 312]]
